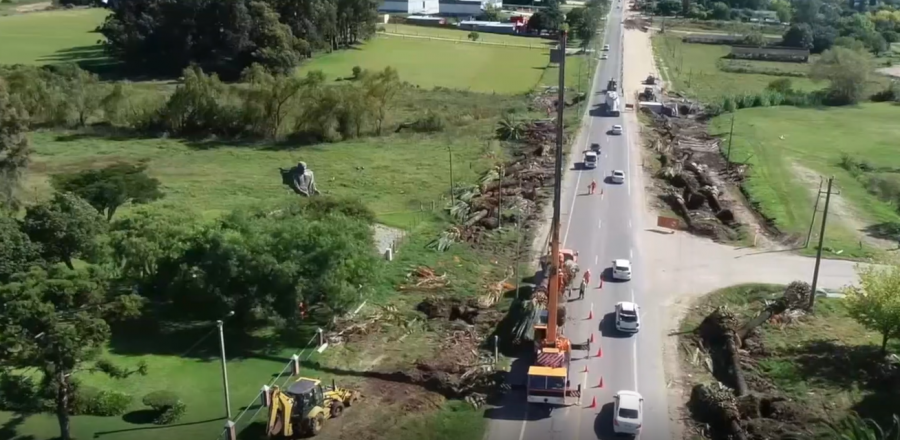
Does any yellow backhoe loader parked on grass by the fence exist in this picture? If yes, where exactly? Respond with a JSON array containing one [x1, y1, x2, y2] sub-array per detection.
[[268, 377, 360, 439]]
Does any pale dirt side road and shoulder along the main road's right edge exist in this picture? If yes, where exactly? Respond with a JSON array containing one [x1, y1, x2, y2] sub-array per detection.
[[623, 12, 856, 439]]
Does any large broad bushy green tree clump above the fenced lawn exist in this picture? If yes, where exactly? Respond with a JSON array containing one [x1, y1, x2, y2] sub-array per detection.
[[145, 201, 381, 329]]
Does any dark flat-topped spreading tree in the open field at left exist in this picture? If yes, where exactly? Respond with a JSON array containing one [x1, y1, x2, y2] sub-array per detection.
[[51, 164, 163, 221]]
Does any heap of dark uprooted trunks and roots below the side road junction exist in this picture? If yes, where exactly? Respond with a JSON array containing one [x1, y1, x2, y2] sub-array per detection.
[[688, 281, 812, 439]]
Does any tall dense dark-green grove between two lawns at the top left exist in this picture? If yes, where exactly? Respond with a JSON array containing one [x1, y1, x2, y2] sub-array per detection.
[[98, 0, 378, 79]]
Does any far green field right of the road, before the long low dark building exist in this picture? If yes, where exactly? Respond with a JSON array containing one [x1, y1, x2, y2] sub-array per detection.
[[652, 34, 823, 102]]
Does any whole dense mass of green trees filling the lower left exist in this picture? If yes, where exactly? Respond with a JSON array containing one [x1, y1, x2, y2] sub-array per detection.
[[0, 192, 382, 439]]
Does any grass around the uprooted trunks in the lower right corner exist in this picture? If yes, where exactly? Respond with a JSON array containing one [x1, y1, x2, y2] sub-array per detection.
[[680, 284, 900, 438]]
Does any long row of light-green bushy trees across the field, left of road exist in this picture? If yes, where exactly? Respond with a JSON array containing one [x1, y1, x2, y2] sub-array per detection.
[[0, 64, 403, 141]]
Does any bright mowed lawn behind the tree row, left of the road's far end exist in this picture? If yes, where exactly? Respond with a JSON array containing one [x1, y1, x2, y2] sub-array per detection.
[[300, 35, 549, 94]]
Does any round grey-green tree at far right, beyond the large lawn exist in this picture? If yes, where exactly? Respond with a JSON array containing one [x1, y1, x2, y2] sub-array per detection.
[[810, 47, 872, 104]]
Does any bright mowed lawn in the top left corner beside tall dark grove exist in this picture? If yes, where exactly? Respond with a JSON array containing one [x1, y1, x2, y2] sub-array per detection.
[[0, 8, 109, 64]]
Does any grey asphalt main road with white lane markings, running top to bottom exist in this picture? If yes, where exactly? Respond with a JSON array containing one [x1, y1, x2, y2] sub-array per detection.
[[487, 3, 670, 440]]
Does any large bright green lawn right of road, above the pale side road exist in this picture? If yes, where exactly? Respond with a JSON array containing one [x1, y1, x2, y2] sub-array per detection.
[[710, 104, 900, 256]]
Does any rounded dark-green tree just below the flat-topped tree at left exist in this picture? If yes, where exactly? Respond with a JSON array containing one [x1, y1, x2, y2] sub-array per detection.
[[22, 193, 106, 269]]
